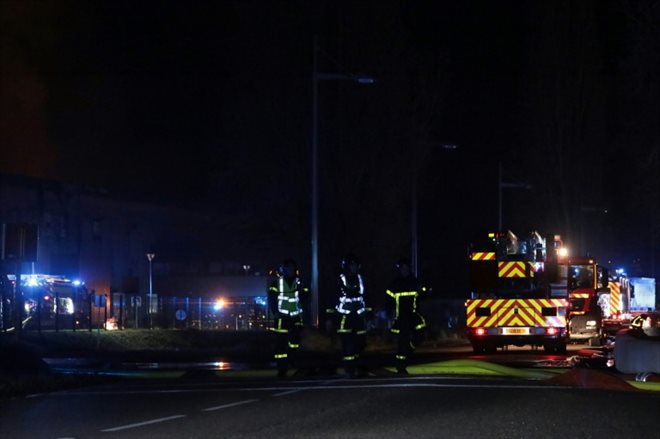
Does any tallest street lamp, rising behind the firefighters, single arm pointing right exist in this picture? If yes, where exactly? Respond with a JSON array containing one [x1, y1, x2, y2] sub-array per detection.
[[311, 35, 376, 326]]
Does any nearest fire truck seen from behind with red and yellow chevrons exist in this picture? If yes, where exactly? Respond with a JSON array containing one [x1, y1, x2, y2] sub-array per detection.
[[465, 231, 569, 353]]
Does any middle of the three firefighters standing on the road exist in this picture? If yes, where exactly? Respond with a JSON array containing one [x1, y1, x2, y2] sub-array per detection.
[[335, 254, 367, 378]]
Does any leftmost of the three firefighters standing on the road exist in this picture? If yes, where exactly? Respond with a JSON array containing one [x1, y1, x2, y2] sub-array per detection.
[[268, 259, 309, 377]]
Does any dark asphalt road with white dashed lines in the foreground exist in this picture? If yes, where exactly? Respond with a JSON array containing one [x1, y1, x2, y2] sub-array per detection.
[[0, 376, 660, 439]]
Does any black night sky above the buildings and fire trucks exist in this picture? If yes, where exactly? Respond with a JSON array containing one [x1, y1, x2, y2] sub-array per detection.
[[0, 0, 660, 302]]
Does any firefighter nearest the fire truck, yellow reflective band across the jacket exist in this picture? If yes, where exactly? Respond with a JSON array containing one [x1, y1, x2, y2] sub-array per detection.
[[386, 258, 426, 375]]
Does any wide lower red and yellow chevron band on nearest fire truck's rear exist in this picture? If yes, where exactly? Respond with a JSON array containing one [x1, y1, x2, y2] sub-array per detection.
[[466, 299, 568, 328]]
